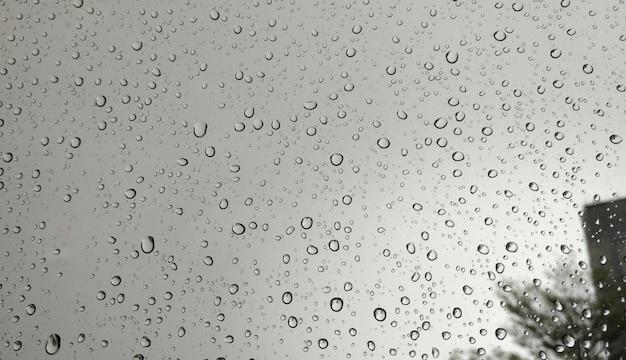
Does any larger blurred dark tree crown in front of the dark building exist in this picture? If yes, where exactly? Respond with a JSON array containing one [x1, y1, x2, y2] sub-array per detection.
[[492, 264, 624, 360]]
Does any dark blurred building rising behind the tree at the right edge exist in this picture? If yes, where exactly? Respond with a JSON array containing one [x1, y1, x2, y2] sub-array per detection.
[[582, 199, 626, 360]]
